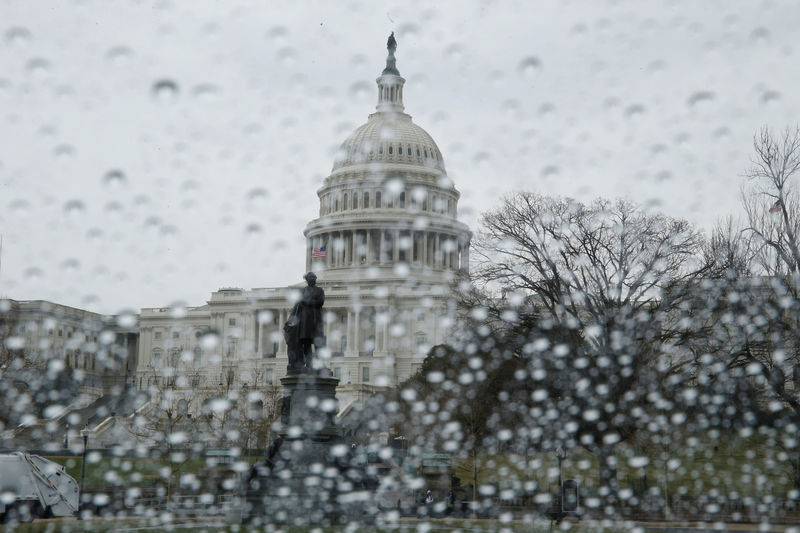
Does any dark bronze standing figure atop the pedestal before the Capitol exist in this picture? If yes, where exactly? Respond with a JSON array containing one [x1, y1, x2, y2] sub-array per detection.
[[283, 272, 325, 374]]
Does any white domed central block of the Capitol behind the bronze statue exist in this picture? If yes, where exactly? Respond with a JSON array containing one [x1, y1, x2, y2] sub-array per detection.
[[137, 34, 470, 405]]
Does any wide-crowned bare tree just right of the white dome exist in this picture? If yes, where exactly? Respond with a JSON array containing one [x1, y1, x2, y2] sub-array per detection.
[[470, 193, 705, 500]]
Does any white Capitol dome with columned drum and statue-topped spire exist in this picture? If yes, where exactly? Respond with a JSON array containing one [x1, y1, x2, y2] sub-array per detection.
[[304, 34, 471, 287]]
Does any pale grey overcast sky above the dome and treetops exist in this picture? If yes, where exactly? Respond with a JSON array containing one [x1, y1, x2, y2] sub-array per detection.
[[0, 0, 800, 312]]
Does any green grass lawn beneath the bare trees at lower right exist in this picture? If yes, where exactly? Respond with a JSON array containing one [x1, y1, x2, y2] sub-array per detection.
[[454, 431, 800, 499]]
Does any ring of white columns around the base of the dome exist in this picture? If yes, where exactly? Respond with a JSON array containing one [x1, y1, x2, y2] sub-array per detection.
[[306, 229, 469, 270]]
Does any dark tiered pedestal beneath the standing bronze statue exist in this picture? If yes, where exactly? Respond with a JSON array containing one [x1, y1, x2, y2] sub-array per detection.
[[243, 374, 374, 525]]
